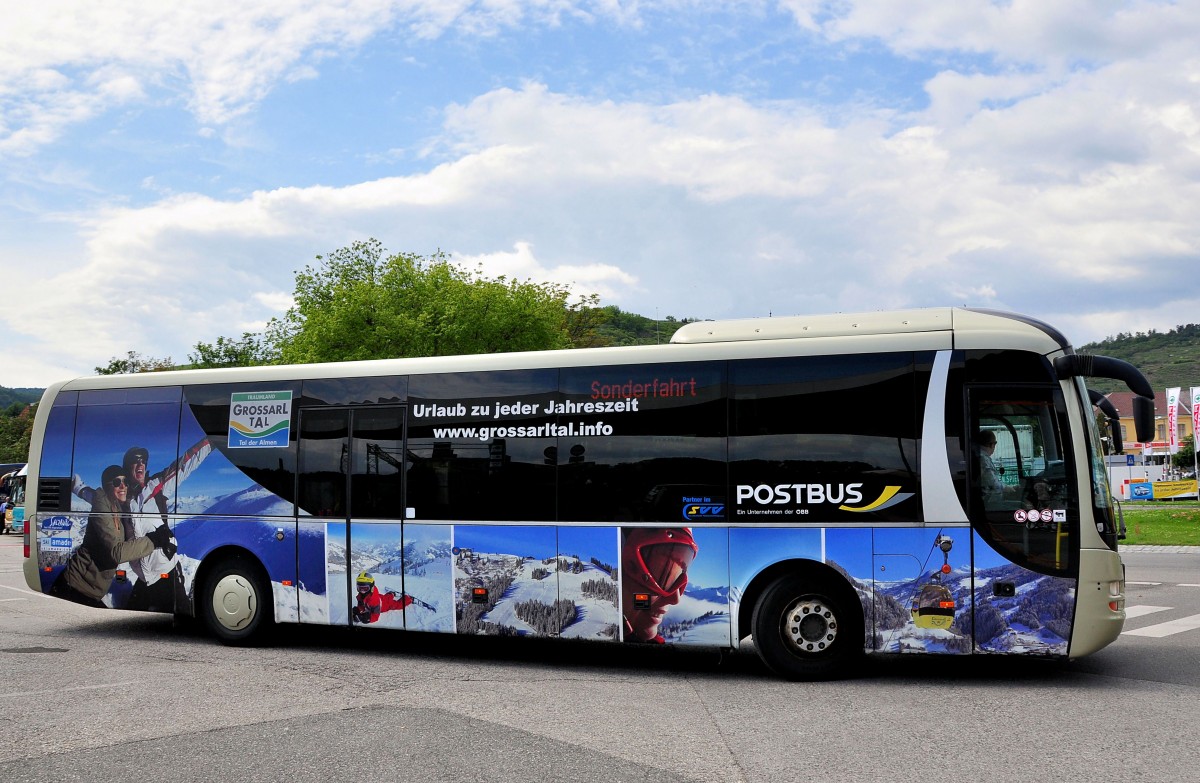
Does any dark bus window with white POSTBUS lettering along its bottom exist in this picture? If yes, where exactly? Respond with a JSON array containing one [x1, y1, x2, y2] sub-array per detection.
[[730, 353, 929, 522]]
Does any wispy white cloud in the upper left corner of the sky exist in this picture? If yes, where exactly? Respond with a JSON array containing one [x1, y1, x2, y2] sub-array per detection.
[[0, 0, 681, 156]]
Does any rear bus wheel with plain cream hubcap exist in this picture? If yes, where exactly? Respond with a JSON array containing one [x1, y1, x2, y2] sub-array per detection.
[[199, 557, 275, 646]]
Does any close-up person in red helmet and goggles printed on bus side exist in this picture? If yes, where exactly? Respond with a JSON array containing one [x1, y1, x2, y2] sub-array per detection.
[[620, 527, 700, 644]]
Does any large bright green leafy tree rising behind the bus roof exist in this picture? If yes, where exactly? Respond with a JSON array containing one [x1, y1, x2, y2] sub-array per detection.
[[265, 239, 595, 363]]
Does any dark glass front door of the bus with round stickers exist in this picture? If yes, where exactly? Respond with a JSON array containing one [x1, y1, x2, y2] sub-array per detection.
[[970, 387, 1079, 573]]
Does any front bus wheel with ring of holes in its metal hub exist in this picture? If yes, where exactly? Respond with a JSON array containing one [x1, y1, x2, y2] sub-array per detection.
[[751, 575, 863, 680]]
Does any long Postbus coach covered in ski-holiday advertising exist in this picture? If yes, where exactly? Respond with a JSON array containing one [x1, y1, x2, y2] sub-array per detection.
[[24, 307, 1153, 680]]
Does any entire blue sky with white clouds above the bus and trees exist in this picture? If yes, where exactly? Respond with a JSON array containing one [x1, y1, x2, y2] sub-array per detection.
[[0, 0, 1200, 387]]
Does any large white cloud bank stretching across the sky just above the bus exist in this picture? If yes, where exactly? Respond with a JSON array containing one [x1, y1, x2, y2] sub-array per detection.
[[7, 64, 1200, 389]]
